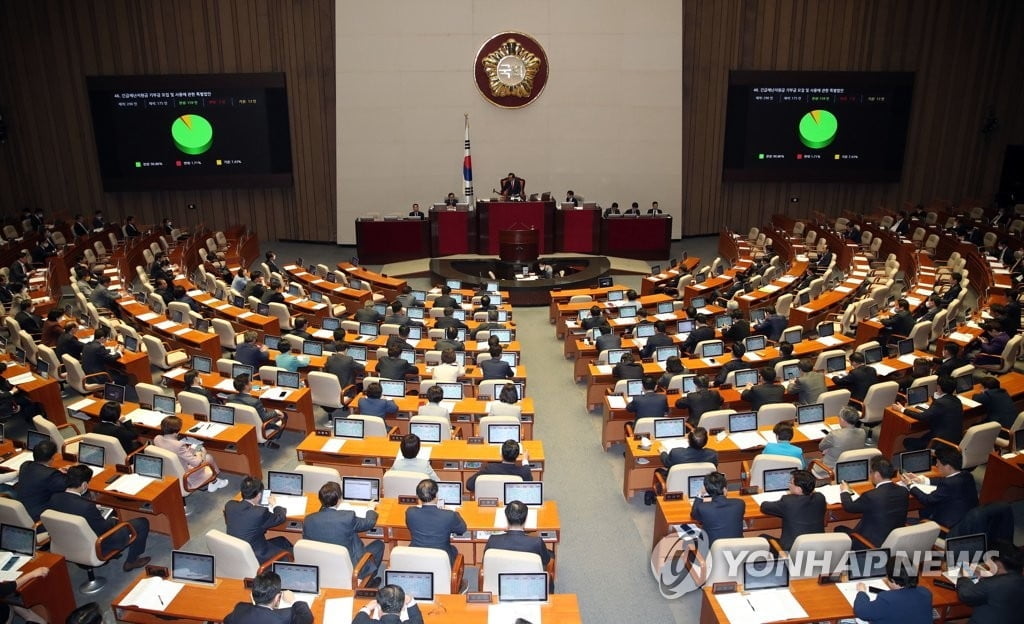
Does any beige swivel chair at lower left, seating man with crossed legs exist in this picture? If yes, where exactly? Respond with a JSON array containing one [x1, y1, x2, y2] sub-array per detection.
[[40, 509, 140, 594]]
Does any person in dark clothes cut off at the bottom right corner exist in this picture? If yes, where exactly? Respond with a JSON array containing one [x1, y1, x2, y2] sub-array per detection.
[[956, 542, 1024, 624]]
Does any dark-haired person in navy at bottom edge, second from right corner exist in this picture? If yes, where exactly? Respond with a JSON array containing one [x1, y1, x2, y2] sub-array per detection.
[[853, 556, 932, 624]]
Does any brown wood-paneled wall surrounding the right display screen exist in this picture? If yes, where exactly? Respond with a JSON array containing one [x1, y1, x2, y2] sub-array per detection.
[[681, 0, 1024, 236]]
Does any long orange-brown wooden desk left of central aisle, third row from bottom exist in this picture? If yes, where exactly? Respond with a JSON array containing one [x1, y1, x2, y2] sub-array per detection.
[[295, 433, 545, 484]]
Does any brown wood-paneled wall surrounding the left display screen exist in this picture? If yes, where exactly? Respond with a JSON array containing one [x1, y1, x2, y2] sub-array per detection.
[[0, 0, 336, 241]]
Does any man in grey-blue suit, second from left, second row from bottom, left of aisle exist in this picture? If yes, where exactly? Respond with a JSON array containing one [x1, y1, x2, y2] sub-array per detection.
[[302, 481, 384, 578]]
